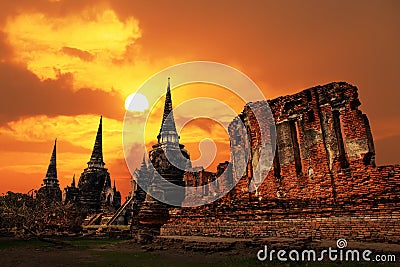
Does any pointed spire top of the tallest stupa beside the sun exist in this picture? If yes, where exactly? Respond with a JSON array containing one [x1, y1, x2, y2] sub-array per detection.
[[157, 77, 179, 143]]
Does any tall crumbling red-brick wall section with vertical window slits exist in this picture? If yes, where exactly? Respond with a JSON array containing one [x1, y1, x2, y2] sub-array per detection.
[[238, 80, 375, 202]]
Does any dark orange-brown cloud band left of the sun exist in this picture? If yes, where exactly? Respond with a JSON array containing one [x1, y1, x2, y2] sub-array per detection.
[[0, 62, 124, 125]]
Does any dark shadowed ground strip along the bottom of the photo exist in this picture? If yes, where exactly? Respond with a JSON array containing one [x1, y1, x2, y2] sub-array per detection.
[[0, 237, 400, 267]]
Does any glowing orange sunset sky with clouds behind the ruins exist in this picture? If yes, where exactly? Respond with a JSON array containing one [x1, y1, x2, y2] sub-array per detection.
[[0, 0, 400, 200]]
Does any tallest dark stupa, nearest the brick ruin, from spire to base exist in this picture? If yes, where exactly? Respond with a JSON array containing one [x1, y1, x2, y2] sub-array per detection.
[[132, 78, 191, 238]]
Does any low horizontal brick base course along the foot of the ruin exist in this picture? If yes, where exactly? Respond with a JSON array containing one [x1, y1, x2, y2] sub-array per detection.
[[161, 214, 400, 243]]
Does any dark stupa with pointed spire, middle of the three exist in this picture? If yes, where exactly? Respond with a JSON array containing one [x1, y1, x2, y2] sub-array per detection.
[[65, 117, 121, 214]]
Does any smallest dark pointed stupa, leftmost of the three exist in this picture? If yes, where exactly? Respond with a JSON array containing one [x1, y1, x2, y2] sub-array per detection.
[[37, 140, 62, 201]]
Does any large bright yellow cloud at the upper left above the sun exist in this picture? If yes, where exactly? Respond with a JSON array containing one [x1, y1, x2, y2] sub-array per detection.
[[4, 5, 147, 97]]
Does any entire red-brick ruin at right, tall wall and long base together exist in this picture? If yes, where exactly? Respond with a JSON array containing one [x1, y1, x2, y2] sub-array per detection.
[[161, 82, 400, 242]]
